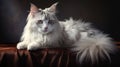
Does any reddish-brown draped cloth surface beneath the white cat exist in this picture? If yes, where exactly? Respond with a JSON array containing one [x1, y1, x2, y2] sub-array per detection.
[[0, 42, 120, 67]]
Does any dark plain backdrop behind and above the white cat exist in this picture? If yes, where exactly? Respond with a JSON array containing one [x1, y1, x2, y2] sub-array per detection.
[[0, 0, 120, 43]]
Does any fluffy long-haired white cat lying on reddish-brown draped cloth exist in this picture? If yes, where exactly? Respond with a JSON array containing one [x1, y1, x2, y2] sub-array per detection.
[[17, 3, 116, 63]]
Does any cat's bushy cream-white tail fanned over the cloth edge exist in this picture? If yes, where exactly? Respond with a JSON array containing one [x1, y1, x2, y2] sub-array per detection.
[[73, 33, 115, 63]]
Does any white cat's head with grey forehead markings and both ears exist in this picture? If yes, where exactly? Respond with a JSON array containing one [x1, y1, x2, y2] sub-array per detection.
[[27, 3, 59, 34]]
